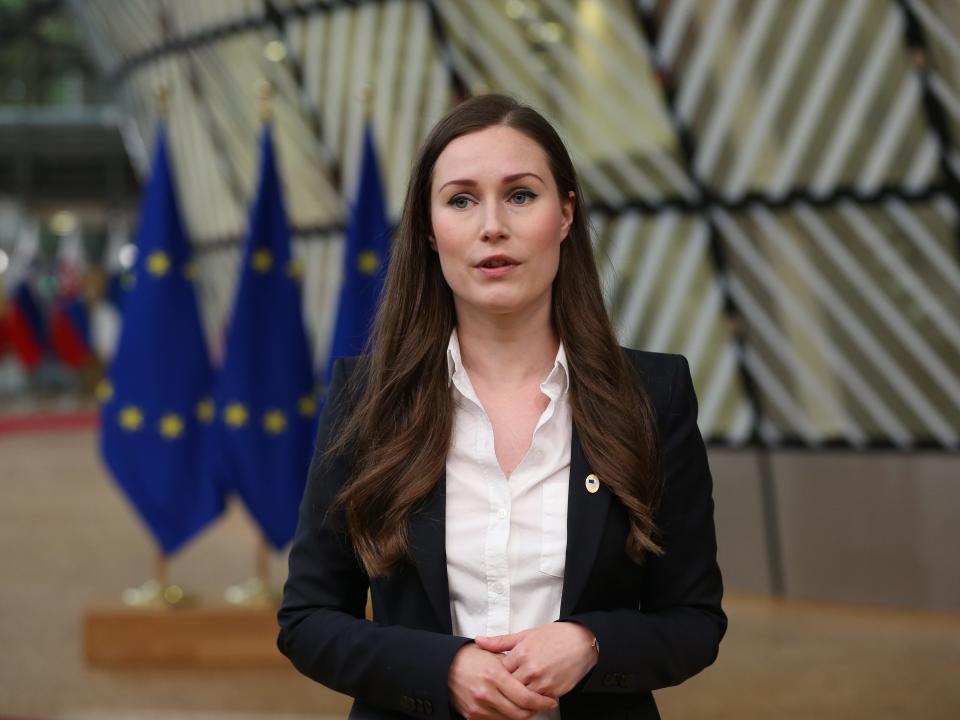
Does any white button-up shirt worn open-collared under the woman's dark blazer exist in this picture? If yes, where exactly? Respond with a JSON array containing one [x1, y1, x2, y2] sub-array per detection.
[[446, 330, 572, 704]]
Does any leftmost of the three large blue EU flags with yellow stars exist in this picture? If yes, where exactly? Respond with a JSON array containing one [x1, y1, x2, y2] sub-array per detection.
[[97, 128, 223, 554]]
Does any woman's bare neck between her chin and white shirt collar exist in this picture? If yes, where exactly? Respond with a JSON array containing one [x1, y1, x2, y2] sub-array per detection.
[[457, 303, 560, 385]]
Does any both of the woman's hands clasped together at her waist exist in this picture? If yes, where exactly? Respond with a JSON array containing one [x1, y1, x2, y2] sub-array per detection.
[[449, 622, 597, 720]]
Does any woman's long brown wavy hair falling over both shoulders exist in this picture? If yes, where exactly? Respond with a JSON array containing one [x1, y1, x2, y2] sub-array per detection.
[[327, 94, 661, 576]]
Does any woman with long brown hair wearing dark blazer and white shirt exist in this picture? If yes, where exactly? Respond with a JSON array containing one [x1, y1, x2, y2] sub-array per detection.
[[278, 95, 726, 720]]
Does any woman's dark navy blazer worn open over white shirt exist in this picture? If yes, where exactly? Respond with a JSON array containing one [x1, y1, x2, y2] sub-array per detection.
[[278, 350, 727, 720]]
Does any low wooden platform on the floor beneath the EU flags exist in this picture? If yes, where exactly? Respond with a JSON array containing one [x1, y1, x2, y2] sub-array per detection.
[[83, 606, 290, 668]]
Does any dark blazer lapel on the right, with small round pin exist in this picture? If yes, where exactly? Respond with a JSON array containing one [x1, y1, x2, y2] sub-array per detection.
[[560, 428, 611, 617]]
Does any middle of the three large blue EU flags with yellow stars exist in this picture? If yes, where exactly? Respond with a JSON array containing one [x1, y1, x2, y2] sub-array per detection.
[[214, 127, 317, 550]]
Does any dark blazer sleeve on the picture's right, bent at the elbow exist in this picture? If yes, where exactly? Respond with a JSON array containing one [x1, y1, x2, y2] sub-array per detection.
[[560, 356, 727, 693]]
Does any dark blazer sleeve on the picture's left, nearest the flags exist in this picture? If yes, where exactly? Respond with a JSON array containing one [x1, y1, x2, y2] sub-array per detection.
[[277, 360, 468, 718]]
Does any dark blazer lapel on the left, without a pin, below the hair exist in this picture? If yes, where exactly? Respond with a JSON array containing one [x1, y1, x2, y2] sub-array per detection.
[[409, 474, 453, 633]]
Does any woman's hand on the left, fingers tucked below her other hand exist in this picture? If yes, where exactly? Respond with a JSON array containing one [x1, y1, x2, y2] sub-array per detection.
[[447, 643, 557, 720]]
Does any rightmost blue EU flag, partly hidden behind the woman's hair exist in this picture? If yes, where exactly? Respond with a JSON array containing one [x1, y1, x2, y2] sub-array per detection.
[[326, 125, 392, 384]]
